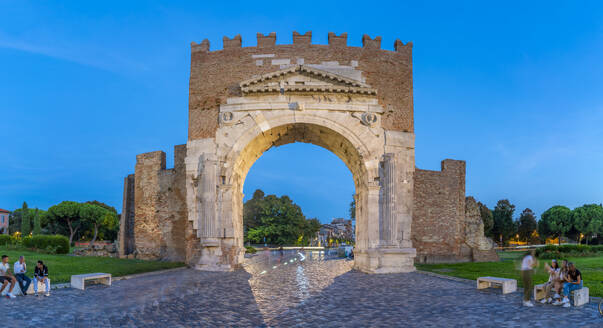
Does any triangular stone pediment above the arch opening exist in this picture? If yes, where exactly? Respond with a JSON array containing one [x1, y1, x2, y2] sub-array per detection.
[[239, 65, 377, 95]]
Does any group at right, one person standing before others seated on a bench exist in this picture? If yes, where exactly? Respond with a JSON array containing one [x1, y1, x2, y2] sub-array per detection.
[[521, 250, 583, 307]]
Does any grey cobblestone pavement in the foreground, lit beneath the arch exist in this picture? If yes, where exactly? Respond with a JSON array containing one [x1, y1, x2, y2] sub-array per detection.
[[0, 252, 603, 327]]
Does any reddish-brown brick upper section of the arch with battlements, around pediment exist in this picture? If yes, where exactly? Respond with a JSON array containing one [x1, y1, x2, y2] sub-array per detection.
[[189, 32, 414, 140]]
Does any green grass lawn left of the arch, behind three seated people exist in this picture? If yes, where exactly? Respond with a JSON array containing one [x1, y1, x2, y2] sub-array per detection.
[[0, 247, 184, 283]]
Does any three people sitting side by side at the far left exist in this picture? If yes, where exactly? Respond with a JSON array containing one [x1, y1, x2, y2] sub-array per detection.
[[0, 255, 50, 298]]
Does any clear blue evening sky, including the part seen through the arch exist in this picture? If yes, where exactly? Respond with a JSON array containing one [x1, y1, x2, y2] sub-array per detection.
[[0, 0, 603, 221]]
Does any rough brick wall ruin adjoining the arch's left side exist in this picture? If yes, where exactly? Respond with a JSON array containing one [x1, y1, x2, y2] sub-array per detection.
[[130, 145, 188, 261]]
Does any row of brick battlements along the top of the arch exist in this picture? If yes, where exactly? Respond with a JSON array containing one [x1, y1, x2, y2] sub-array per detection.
[[191, 31, 412, 52]]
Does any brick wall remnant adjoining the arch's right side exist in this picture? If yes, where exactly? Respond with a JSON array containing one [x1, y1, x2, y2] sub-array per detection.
[[411, 159, 471, 263]]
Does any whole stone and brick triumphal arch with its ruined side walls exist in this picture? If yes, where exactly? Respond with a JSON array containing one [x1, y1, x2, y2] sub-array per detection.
[[119, 32, 495, 273]]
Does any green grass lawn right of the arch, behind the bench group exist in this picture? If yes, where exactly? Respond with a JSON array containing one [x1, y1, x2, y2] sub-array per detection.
[[416, 252, 603, 297]]
